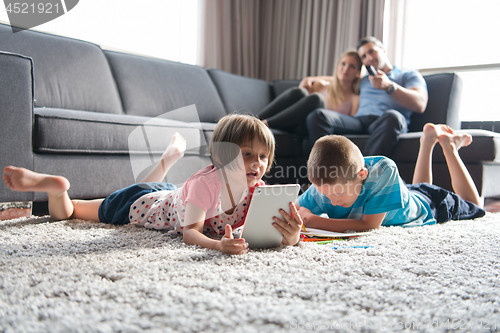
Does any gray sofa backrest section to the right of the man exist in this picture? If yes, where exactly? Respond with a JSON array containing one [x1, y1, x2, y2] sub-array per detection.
[[408, 73, 462, 132]]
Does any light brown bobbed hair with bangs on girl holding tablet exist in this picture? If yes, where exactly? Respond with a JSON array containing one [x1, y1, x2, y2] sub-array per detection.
[[210, 113, 276, 172]]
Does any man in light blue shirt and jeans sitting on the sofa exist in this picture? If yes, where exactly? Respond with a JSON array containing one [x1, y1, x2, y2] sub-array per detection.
[[306, 37, 428, 157]]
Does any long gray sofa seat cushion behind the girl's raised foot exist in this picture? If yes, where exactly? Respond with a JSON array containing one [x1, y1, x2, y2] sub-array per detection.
[[33, 108, 206, 155]]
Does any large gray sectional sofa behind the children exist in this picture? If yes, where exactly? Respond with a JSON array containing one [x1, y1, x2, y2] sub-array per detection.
[[0, 24, 500, 211]]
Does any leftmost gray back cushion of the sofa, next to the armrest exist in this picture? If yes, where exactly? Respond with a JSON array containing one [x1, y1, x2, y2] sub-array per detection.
[[0, 24, 122, 113]]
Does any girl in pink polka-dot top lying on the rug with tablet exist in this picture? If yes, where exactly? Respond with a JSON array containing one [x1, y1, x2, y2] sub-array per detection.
[[3, 114, 302, 254]]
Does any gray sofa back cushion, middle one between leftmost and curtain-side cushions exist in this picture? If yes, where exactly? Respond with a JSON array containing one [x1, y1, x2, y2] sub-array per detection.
[[105, 51, 226, 122]]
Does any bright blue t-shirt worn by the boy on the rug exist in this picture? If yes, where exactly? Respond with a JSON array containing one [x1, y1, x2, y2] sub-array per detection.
[[299, 156, 436, 227]]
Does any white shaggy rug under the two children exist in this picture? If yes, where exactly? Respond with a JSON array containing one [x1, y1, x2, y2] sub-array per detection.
[[0, 213, 500, 332]]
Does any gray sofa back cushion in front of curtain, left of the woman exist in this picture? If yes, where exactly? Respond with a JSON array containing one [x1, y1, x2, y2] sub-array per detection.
[[208, 69, 274, 114]]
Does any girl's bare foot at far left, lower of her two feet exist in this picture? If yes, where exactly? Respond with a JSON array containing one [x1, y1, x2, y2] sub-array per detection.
[[3, 166, 69, 194]]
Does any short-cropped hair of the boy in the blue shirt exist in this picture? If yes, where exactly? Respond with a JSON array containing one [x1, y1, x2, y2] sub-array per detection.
[[307, 135, 365, 186]]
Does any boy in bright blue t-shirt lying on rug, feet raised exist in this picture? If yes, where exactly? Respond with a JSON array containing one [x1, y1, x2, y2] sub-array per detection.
[[298, 124, 485, 232]]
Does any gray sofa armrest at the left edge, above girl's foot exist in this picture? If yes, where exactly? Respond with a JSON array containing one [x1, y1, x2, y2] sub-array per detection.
[[0, 52, 34, 202]]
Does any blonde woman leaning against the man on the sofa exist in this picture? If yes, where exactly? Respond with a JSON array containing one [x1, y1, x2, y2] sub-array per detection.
[[259, 51, 362, 136]]
